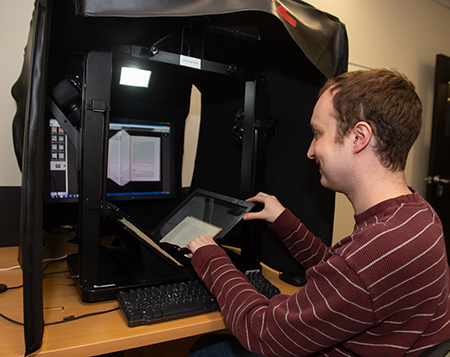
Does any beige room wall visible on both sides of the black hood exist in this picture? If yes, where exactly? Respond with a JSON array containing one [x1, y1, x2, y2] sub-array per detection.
[[0, 0, 450, 240]]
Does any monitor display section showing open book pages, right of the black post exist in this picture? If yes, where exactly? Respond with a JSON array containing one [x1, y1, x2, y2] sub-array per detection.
[[106, 118, 174, 201]]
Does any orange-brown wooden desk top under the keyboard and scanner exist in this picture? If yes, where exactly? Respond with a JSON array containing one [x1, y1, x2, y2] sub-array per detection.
[[0, 234, 298, 357]]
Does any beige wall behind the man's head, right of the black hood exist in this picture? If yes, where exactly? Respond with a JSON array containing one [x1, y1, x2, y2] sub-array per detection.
[[307, 0, 450, 241]]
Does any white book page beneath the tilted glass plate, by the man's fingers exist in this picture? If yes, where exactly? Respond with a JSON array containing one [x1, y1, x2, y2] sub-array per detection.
[[161, 216, 222, 248]]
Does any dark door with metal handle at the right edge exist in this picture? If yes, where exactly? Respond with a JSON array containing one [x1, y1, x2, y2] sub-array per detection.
[[426, 55, 450, 262]]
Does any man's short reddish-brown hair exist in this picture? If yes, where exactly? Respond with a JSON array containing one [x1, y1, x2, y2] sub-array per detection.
[[319, 69, 422, 171]]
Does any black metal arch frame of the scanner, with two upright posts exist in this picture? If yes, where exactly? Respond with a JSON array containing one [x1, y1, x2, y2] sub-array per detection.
[[66, 43, 269, 302]]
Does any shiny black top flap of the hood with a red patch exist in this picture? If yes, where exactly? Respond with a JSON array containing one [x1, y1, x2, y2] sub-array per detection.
[[74, 0, 348, 78]]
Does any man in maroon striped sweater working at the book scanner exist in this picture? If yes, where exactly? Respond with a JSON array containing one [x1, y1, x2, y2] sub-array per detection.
[[187, 69, 450, 357]]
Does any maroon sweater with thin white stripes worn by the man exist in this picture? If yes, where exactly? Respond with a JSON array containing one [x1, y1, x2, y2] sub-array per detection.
[[192, 192, 450, 357]]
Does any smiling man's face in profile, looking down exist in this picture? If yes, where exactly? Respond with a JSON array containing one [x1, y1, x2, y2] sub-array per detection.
[[307, 91, 351, 193]]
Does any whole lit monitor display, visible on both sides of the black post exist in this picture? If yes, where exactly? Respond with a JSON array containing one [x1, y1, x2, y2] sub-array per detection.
[[45, 119, 174, 202]]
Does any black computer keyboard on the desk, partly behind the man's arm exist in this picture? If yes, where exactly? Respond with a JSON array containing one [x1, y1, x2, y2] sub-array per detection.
[[117, 271, 280, 327]]
